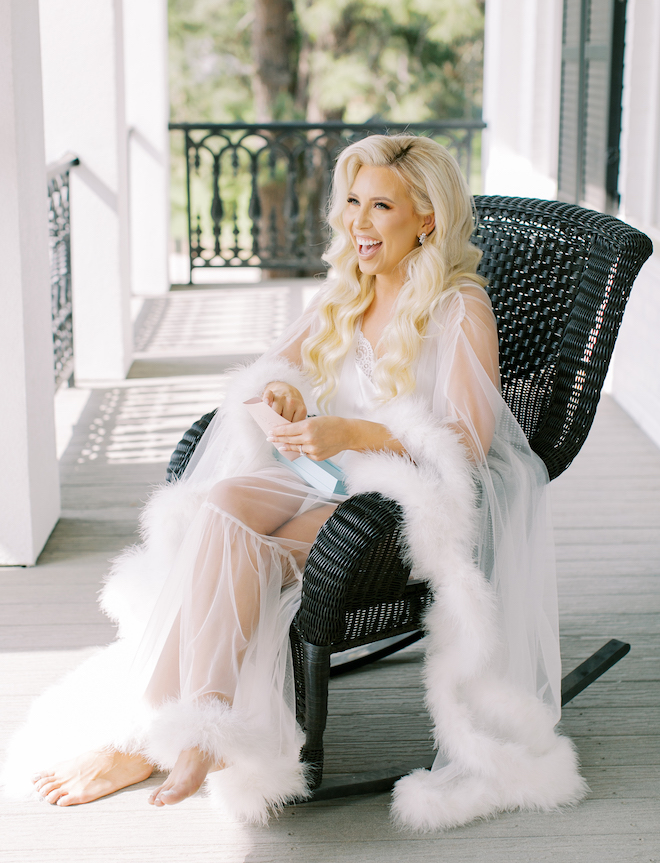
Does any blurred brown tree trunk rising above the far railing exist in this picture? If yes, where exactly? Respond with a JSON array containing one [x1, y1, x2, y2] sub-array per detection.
[[252, 0, 297, 123]]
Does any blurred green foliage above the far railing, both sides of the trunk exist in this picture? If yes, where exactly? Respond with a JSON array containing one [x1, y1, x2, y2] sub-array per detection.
[[169, 0, 484, 122]]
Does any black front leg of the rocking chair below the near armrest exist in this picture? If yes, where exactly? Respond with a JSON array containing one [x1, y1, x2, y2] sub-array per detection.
[[300, 641, 330, 790]]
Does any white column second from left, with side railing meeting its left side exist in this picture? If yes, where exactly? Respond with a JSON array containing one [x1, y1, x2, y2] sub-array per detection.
[[40, 0, 132, 383]]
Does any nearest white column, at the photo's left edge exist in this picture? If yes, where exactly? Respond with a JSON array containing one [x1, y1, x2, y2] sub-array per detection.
[[0, 0, 60, 565]]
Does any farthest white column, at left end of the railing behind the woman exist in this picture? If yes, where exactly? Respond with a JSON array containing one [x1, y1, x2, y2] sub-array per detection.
[[124, 0, 170, 294]]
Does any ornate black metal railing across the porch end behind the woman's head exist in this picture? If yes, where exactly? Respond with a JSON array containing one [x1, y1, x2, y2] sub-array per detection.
[[170, 120, 485, 284]]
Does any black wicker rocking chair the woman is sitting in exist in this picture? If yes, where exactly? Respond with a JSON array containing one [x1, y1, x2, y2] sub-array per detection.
[[168, 196, 652, 800]]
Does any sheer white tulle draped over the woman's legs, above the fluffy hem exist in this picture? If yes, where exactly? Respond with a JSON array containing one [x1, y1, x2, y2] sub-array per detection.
[[132, 465, 337, 751]]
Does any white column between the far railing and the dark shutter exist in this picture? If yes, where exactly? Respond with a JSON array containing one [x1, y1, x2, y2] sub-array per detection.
[[483, 0, 562, 198]]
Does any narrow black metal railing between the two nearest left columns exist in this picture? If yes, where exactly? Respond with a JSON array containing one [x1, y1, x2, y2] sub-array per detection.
[[47, 157, 80, 389]]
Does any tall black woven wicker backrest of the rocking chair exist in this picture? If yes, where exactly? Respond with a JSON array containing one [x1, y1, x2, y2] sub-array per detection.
[[473, 195, 653, 479]]
